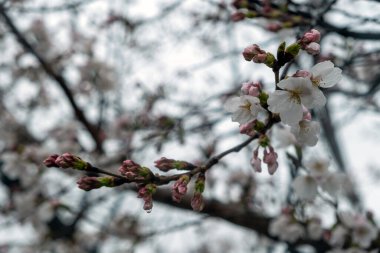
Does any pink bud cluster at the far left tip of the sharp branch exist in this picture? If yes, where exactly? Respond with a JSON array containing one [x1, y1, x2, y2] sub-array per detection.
[[43, 153, 92, 170]]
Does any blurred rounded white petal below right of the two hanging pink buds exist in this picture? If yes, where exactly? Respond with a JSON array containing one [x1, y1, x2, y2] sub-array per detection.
[[292, 175, 318, 200]]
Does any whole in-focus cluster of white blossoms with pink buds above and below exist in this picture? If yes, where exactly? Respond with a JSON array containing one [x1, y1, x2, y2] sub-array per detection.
[[225, 29, 342, 174]]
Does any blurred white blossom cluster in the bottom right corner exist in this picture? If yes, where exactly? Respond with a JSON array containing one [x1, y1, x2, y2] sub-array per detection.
[[269, 208, 379, 253]]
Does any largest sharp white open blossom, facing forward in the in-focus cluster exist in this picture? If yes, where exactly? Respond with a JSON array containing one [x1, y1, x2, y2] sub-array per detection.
[[268, 77, 323, 125]]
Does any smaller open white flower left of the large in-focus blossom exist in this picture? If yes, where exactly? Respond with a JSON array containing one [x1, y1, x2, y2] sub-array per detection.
[[225, 95, 265, 124]]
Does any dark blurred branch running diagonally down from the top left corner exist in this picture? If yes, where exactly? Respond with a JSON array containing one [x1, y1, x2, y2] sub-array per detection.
[[0, 5, 103, 153]]
